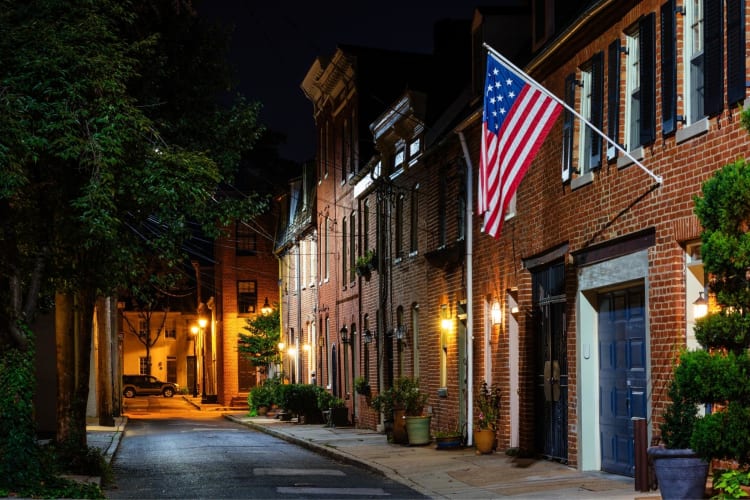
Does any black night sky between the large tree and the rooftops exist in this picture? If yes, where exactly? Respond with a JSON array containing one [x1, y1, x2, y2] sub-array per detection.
[[199, 0, 476, 161]]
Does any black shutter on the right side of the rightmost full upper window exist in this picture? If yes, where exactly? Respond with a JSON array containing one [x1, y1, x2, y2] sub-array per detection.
[[703, 0, 724, 116]]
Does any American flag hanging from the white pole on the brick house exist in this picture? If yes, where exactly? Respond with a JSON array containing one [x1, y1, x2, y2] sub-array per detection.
[[477, 53, 562, 238]]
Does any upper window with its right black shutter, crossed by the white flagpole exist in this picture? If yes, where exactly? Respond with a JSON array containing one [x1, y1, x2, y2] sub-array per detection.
[[578, 52, 604, 175]]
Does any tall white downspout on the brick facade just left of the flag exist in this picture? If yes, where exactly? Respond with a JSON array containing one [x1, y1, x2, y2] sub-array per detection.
[[458, 130, 474, 446]]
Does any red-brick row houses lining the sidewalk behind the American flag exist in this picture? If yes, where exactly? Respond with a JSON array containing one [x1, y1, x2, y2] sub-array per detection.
[[292, 0, 749, 475]]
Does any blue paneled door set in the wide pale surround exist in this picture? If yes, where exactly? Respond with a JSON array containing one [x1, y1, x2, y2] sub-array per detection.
[[598, 286, 647, 476]]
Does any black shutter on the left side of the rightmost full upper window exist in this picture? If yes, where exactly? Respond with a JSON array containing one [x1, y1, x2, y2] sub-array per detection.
[[661, 0, 677, 135]]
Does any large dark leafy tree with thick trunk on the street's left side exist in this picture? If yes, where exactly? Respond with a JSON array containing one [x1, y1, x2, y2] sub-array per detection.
[[0, 0, 265, 484]]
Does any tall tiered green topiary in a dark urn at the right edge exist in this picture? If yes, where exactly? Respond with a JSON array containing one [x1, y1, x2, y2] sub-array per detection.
[[649, 154, 750, 498]]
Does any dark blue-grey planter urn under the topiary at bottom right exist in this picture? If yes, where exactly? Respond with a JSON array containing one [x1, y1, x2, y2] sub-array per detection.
[[647, 446, 708, 500]]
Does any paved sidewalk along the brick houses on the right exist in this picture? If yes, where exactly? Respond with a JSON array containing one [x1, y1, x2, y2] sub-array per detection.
[[225, 413, 660, 500]]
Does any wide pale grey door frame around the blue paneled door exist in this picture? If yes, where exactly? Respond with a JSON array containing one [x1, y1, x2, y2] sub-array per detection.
[[576, 250, 652, 471]]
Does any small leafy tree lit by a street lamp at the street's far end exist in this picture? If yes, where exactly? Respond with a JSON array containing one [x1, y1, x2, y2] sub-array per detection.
[[239, 307, 281, 372]]
